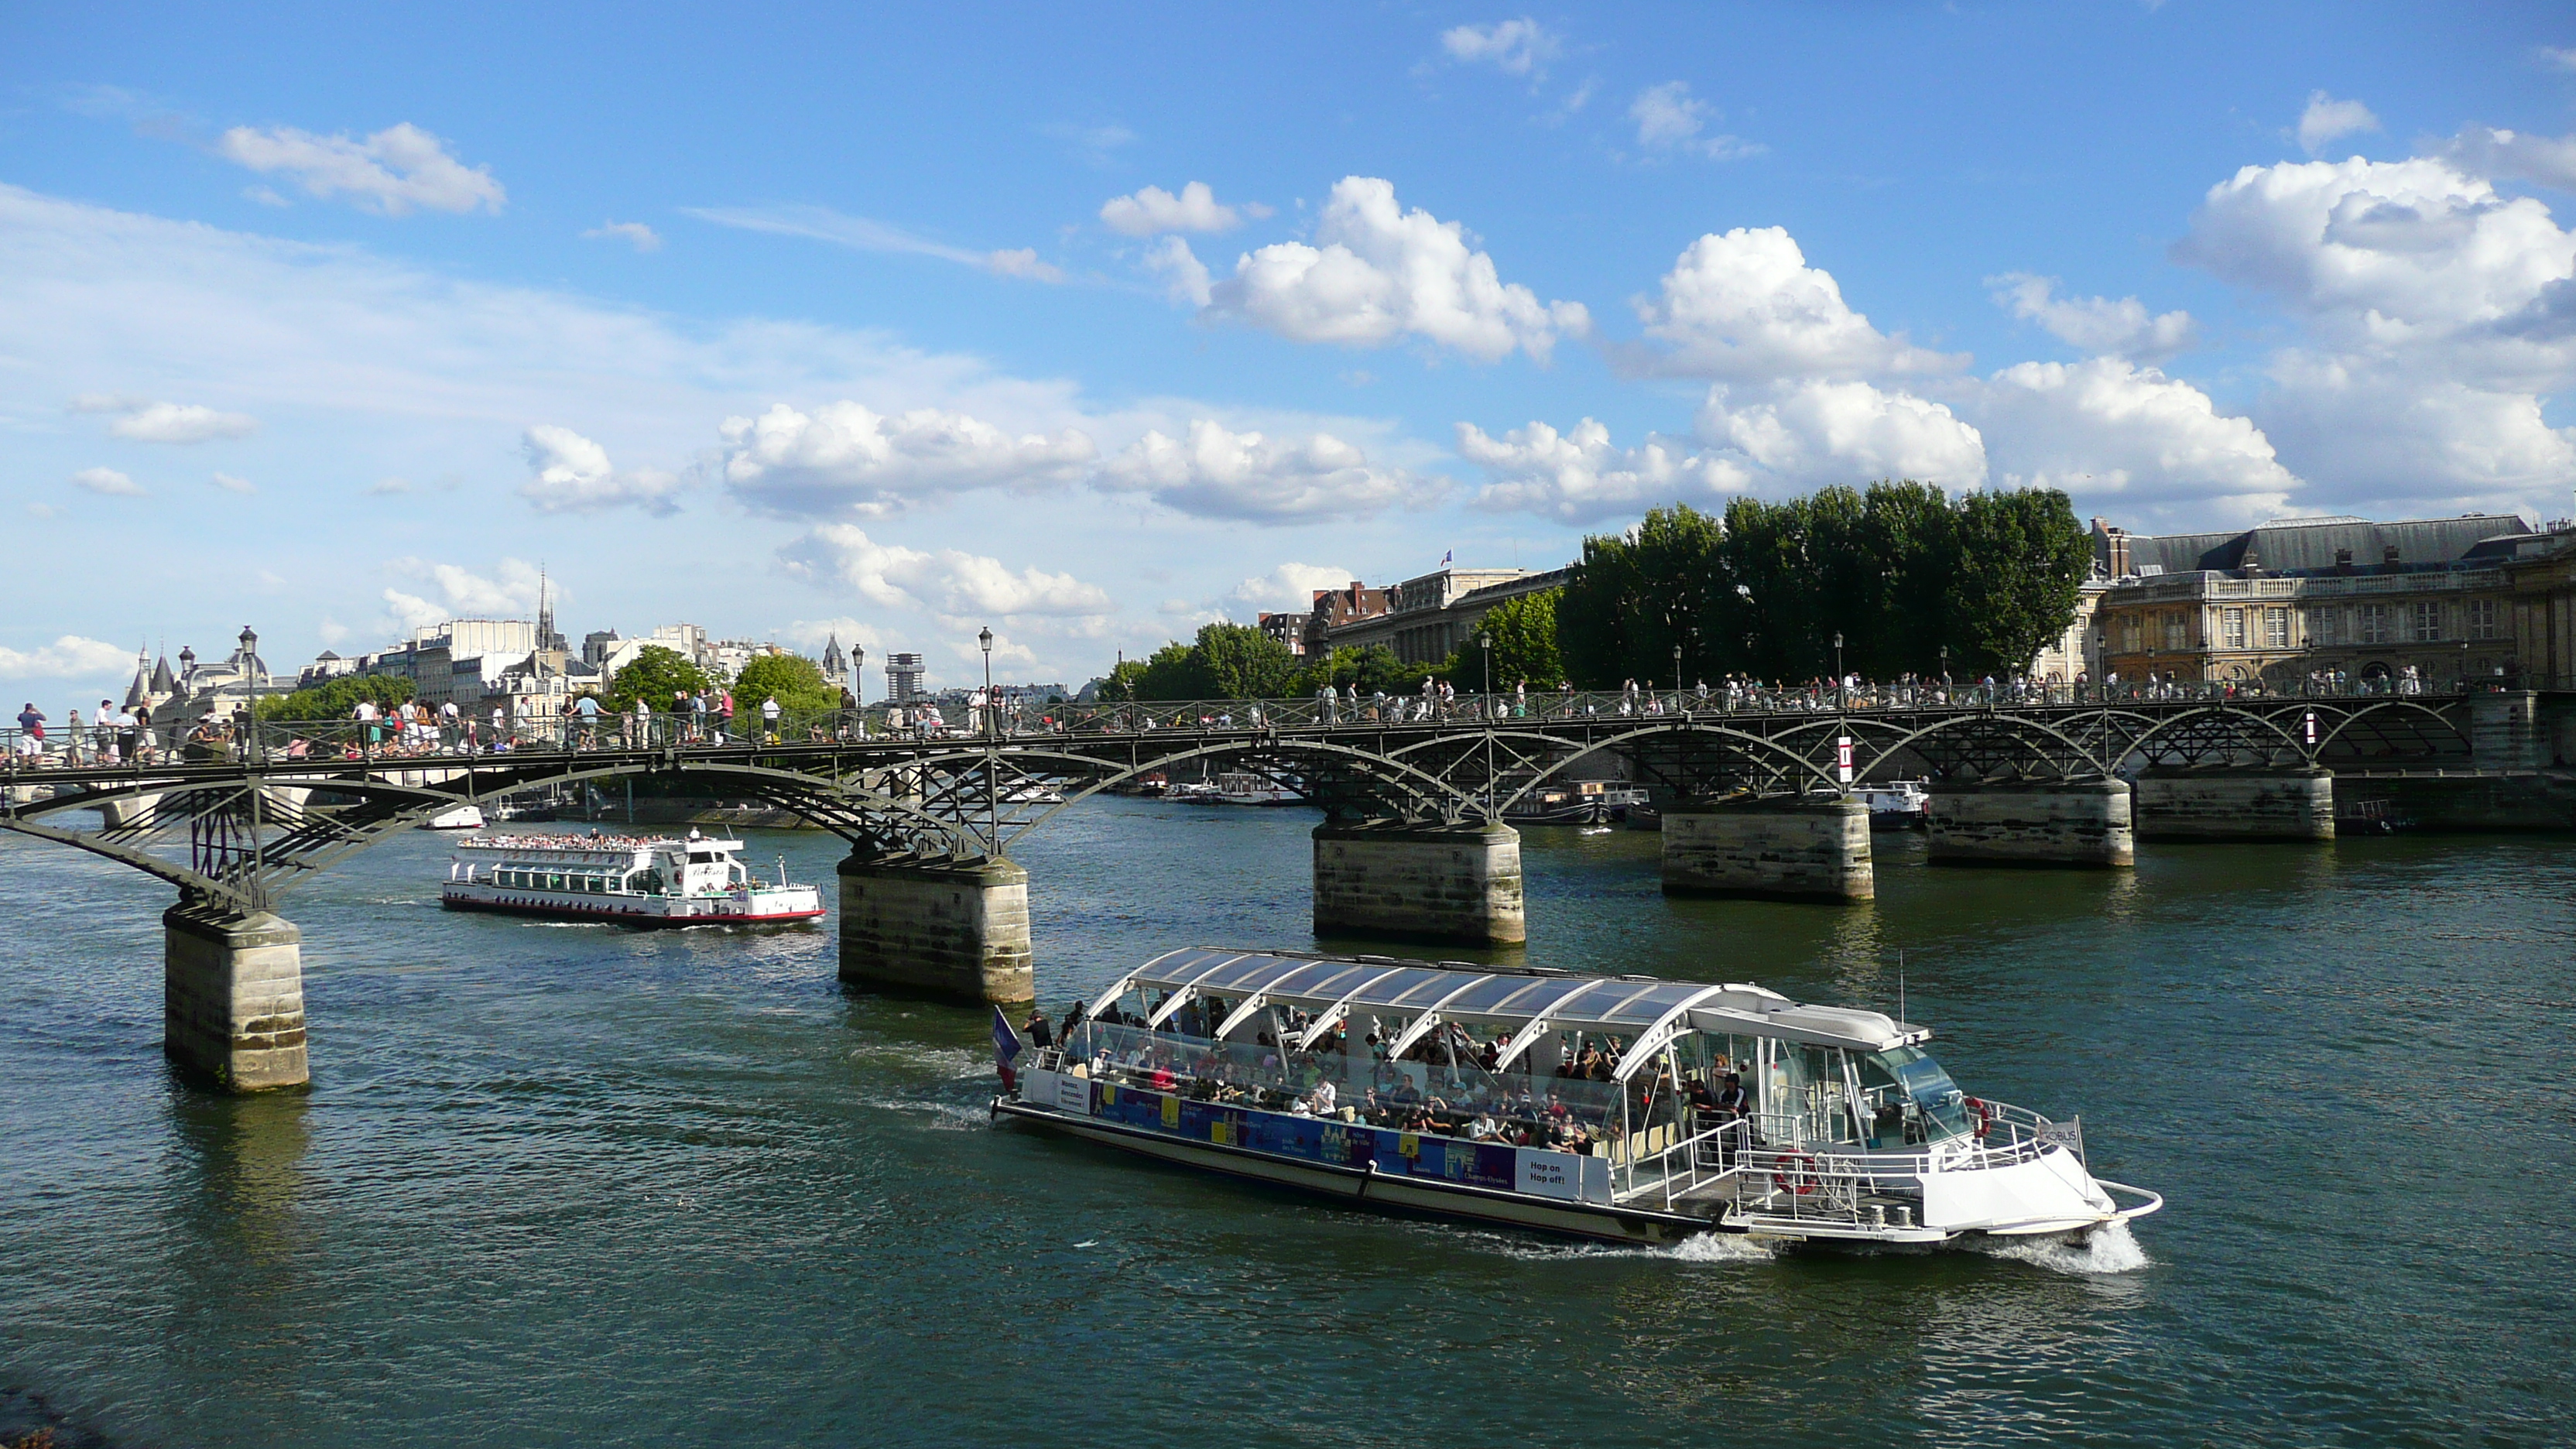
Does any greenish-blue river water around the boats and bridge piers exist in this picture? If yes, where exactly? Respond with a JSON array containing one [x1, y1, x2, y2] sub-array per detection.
[[0, 800, 2576, 1449]]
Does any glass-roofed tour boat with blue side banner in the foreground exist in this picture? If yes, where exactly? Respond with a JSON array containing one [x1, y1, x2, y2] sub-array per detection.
[[995, 949, 2164, 1245]]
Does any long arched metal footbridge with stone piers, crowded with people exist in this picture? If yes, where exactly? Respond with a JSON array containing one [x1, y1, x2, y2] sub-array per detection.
[[0, 686, 2547, 1088]]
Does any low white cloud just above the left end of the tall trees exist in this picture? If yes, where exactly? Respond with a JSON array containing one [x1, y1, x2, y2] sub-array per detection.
[[1458, 418, 1752, 523]]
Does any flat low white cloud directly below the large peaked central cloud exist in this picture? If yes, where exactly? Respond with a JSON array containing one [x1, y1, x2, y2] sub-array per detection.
[[1092, 418, 1437, 523]]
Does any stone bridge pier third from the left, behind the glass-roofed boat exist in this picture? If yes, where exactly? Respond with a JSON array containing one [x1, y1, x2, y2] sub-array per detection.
[[1314, 825, 1530, 946]]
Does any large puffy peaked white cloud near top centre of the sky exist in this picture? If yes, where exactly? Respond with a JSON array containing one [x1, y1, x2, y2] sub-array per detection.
[[1208, 176, 1592, 361]]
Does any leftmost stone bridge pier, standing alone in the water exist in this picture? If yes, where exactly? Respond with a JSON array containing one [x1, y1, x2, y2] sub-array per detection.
[[163, 903, 309, 1091]]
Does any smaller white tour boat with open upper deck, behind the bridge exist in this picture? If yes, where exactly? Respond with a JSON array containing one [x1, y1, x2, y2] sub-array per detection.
[[438, 831, 822, 926]]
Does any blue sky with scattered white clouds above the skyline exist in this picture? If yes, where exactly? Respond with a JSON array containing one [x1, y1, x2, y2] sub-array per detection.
[[0, 0, 2576, 701]]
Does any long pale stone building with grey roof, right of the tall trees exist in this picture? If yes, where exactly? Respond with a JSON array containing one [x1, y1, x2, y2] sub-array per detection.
[[2091, 513, 2576, 686]]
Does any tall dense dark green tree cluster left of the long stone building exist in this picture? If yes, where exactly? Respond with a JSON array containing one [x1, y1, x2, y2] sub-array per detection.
[[1545, 482, 2091, 688]]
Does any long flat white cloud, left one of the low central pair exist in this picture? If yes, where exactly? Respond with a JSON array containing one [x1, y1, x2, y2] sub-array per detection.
[[724, 402, 1098, 519]]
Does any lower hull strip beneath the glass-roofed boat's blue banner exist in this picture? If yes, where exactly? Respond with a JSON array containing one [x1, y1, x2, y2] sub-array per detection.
[[992, 1098, 1736, 1248]]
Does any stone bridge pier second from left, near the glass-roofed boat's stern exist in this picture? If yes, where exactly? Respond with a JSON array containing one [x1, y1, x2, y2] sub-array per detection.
[[840, 856, 1038, 1003]]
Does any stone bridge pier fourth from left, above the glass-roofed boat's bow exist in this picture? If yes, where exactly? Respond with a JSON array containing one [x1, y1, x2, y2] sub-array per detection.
[[1664, 794, 1878, 903]]
